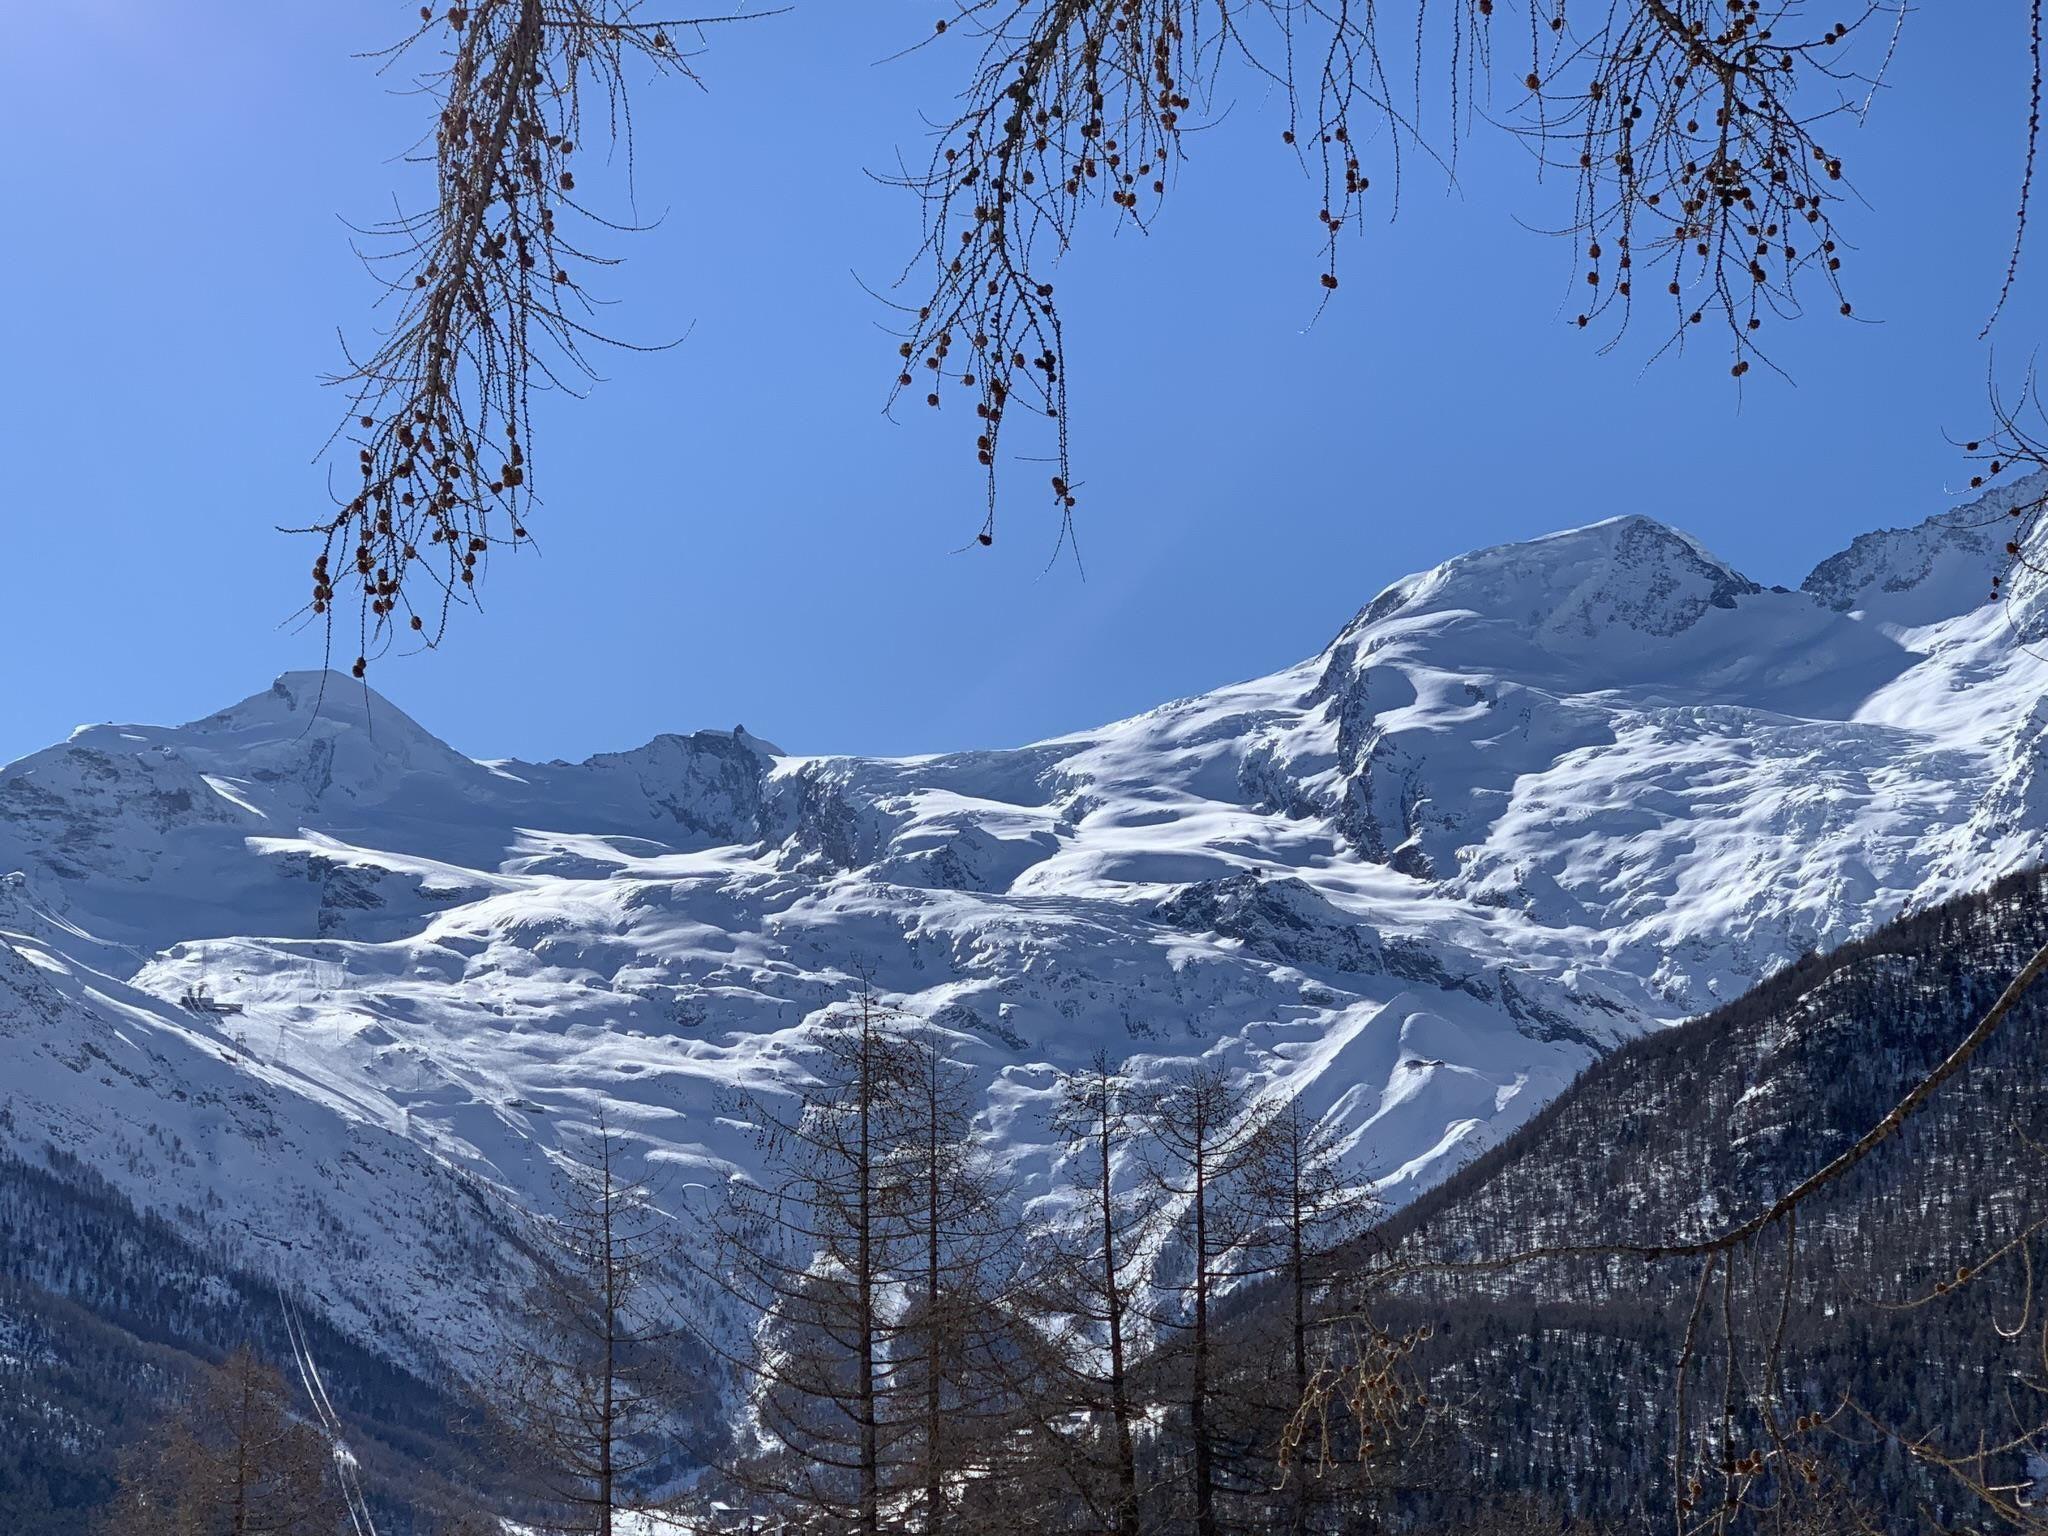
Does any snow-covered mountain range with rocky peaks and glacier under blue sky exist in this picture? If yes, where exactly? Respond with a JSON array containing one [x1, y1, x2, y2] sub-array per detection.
[[0, 481, 2048, 1384]]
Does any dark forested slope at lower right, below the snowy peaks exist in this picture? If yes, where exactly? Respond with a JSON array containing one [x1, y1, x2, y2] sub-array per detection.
[[1354, 872, 2048, 1530]]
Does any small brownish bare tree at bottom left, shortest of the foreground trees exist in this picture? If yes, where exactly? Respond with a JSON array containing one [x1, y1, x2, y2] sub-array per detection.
[[100, 1348, 344, 1536]]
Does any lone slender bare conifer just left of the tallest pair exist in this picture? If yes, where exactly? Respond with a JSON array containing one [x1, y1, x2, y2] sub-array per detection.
[[489, 1114, 692, 1536]]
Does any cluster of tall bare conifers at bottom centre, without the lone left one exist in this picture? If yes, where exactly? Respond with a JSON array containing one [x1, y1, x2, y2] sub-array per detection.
[[702, 1001, 1376, 1536]]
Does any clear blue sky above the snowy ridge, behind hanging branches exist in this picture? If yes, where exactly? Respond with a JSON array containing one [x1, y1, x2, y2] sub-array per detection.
[[0, 0, 2048, 760]]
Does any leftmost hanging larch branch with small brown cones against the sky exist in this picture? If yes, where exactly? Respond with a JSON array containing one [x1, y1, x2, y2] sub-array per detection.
[[297, 0, 749, 678]]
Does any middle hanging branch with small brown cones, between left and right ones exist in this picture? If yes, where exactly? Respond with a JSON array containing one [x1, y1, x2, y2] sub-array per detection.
[[891, 0, 1441, 545]]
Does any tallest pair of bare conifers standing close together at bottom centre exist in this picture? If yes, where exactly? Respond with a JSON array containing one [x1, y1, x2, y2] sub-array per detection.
[[713, 997, 1014, 1536]]
